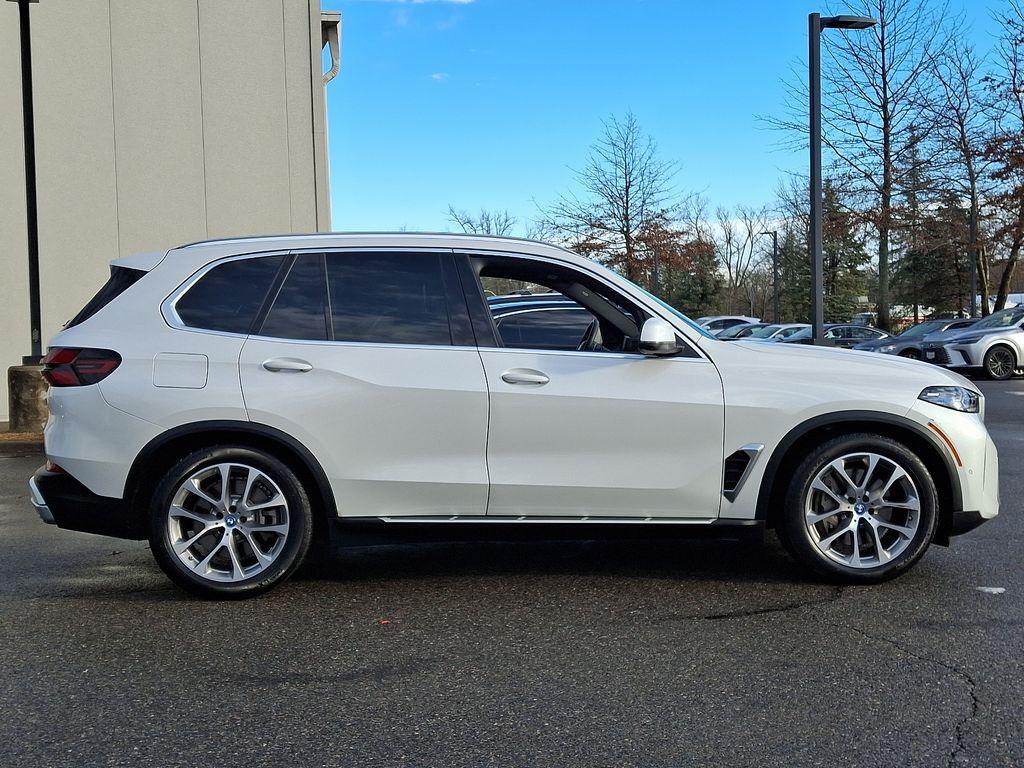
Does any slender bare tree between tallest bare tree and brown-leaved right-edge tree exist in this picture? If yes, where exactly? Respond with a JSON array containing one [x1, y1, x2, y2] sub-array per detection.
[[923, 39, 992, 314]]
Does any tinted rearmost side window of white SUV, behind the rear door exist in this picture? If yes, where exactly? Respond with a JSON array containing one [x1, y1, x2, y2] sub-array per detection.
[[175, 256, 284, 334]]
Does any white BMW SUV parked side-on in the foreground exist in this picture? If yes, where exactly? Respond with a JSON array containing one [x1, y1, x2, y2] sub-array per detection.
[[30, 233, 998, 597]]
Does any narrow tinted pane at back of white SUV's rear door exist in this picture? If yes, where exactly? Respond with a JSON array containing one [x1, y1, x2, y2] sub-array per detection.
[[260, 253, 328, 339]]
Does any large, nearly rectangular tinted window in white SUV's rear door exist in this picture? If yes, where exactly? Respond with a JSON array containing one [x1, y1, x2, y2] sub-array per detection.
[[327, 253, 452, 344]]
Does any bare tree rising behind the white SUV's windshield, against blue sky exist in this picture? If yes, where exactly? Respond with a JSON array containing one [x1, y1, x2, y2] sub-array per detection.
[[543, 114, 678, 283]]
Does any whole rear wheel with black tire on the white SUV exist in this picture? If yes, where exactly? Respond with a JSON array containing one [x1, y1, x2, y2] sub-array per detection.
[[150, 446, 313, 598]]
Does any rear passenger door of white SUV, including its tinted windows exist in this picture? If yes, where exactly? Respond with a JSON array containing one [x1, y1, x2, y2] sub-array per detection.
[[240, 251, 487, 516]]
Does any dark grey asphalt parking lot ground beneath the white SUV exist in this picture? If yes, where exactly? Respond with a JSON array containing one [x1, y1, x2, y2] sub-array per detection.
[[0, 379, 1024, 768]]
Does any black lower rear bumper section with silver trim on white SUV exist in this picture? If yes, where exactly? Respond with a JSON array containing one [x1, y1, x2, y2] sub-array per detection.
[[29, 467, 145, 539]]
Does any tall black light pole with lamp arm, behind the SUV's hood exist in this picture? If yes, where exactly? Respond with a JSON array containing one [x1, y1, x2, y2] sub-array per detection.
[[807, 13, 878, 344]]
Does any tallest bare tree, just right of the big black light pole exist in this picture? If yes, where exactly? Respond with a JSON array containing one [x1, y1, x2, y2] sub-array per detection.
[[768, 0, 949, 328]]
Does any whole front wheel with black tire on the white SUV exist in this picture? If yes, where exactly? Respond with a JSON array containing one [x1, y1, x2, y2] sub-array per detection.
[[777, 434, 938, 584]]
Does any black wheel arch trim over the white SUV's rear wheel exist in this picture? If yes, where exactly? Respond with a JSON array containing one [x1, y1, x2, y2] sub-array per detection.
[[124, 420, 338, 538]]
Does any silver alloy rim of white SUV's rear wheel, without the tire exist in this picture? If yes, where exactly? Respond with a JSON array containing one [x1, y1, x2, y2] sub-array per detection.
[[167, 463, 289, 582]]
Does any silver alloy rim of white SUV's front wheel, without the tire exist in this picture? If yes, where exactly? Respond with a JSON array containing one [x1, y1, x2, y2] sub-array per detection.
[[804, 453, 921, 569]]
